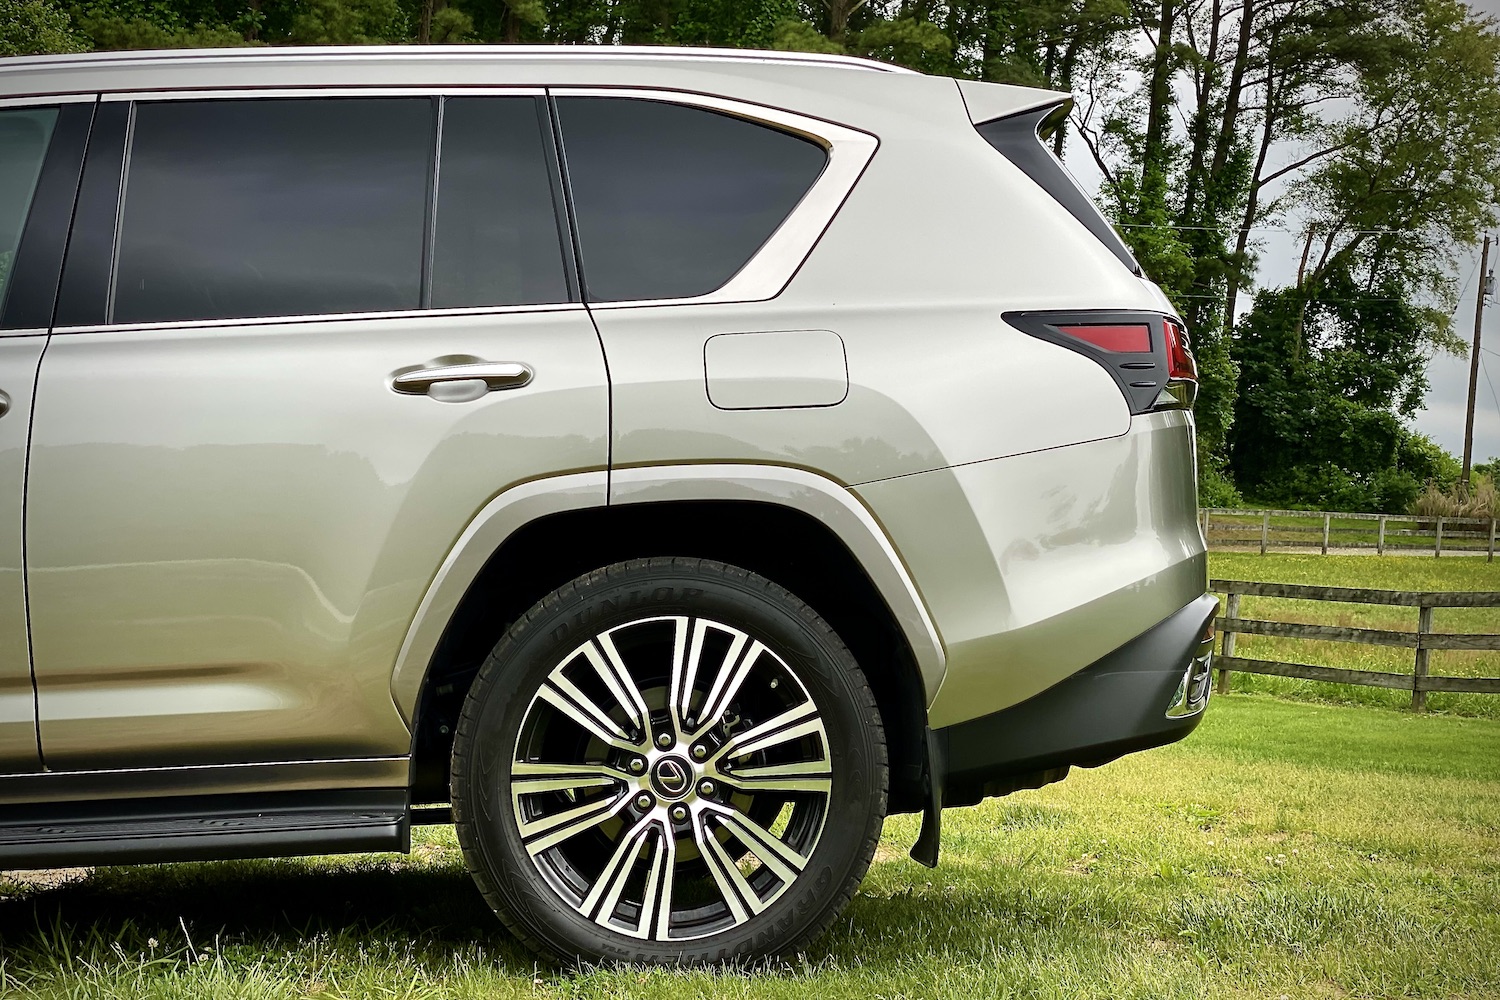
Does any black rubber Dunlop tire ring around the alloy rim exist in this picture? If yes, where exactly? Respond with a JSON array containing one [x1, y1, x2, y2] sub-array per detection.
[[453, 561, 887, 963]]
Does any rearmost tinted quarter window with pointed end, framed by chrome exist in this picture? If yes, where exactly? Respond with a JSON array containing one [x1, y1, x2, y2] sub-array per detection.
[[558, 97, 828, 301]]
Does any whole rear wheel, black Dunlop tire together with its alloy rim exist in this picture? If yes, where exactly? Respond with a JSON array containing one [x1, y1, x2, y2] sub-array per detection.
[[452, 558, 887, 964]]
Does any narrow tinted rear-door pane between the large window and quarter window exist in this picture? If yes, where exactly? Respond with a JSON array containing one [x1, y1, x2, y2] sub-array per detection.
[[432, 97, 569, 309]]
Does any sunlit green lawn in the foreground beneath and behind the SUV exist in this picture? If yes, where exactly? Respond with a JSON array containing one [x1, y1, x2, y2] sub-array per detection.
[[0, 695, 1500, 1000]]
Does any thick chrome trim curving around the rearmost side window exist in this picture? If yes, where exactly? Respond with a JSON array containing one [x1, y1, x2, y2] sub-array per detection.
[[548, 87, 881, 309]]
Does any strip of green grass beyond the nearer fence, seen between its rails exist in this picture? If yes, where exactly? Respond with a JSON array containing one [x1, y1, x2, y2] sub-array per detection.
[[1209, 552, 1500, 718]]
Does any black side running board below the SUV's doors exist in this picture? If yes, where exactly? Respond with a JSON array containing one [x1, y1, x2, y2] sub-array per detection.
[[0, 789, 411, 870]]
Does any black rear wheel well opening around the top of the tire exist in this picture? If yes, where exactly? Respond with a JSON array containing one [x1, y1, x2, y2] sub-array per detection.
[[393, 476, 941, 813]]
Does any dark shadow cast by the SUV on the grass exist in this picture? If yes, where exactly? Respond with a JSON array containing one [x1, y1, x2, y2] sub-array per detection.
[[0, 858, 1116, 978]]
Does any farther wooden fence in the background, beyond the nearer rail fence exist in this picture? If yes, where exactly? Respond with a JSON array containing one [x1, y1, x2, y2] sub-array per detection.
[[1199, 507, 1496, 562]]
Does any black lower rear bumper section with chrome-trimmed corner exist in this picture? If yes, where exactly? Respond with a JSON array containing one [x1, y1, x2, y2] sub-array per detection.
[[930, 594, 1218, 805]]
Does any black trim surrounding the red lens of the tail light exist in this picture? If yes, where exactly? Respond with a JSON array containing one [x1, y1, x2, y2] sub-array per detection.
[[1002, 309, 1197, 414]]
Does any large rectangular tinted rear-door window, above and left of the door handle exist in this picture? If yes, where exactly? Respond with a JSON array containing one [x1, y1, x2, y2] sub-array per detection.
[[114, 97, 437, 322]]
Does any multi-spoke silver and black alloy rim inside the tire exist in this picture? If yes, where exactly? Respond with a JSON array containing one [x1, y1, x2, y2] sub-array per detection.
[[510, 615, 834, 942]]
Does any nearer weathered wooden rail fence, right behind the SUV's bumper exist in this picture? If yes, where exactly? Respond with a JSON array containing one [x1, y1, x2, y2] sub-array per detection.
[[1209, 580, 1500, 712]]
